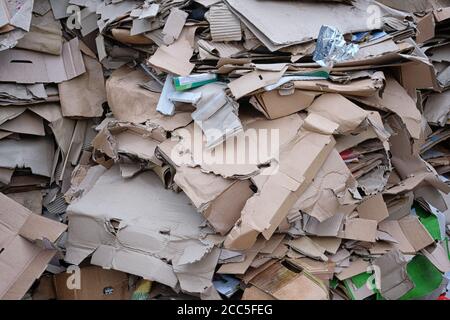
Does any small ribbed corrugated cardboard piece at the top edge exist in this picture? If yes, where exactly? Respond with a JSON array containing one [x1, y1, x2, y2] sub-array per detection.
[[209, 4, 242, 41]]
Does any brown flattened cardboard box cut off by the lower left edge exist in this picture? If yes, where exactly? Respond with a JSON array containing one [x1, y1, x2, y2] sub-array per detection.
[[0, 193, 67, 300]]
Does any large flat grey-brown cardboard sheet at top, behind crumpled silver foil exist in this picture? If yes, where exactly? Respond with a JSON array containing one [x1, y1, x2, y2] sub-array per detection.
[[226, 0, 376, 52]]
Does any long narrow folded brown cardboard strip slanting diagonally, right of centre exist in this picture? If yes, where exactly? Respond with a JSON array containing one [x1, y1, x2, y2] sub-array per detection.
[[225, 131, 335, 249]]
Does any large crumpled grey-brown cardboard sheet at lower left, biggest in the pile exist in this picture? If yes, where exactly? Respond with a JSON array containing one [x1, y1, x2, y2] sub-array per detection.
[[66, 166, 219, 293]]
